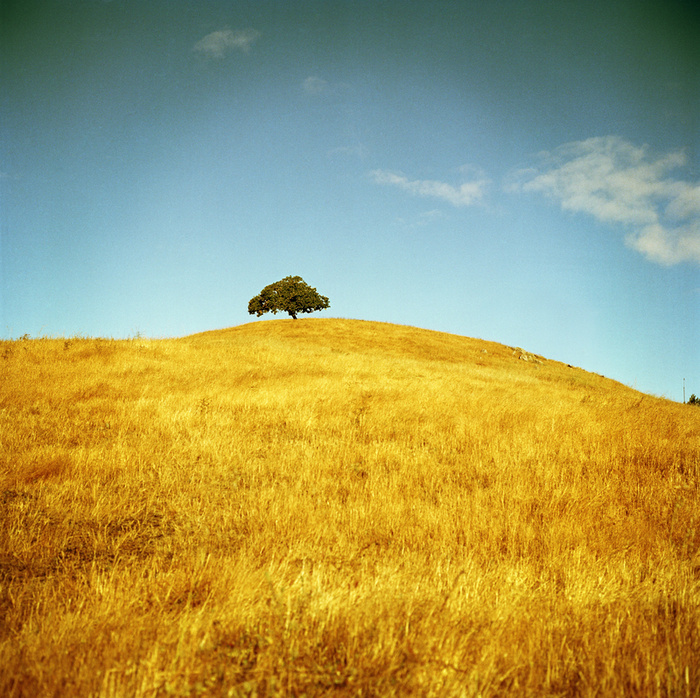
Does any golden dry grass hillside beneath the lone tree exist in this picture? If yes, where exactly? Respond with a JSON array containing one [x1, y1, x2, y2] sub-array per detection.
[[0, 319, 700, 696]]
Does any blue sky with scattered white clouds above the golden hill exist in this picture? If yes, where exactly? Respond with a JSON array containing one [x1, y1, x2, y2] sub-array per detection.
[[0, 0, 700, 400]]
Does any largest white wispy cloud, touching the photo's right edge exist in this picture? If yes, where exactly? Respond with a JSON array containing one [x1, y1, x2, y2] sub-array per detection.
[[507, 136, 700, 265]]
